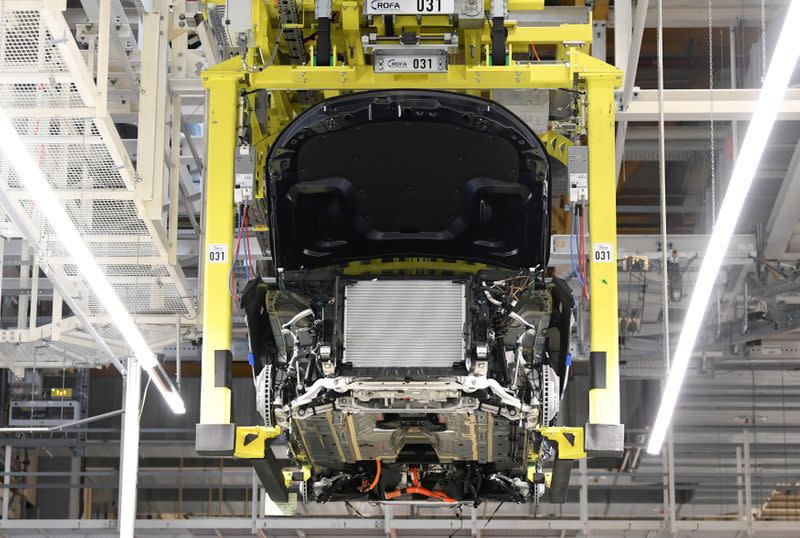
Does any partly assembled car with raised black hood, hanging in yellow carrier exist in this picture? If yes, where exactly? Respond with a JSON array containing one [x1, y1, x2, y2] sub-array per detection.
[[243, 90, 573, 502]]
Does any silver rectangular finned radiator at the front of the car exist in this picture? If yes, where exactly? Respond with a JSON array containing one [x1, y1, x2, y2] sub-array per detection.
[[343, 280, 466, 368]]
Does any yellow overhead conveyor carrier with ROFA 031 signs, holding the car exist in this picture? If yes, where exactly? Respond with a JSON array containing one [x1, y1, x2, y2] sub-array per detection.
[[196, 0, 624, 501]]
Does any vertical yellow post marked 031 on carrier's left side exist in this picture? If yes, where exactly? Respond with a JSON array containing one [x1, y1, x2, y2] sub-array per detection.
[[195, 63, 241, 456]]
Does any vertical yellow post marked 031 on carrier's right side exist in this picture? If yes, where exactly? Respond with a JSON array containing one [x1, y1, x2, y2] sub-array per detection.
[[581, 75, 624, 456]]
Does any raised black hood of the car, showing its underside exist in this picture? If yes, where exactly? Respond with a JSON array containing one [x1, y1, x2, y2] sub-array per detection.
[[267, 90, 550, 270]]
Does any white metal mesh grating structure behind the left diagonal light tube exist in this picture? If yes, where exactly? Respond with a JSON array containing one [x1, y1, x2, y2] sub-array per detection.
[[0, 0, 196, 365]]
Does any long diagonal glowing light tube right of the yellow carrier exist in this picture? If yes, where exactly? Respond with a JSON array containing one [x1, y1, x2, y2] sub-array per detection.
[[647, 0, 800, 454]]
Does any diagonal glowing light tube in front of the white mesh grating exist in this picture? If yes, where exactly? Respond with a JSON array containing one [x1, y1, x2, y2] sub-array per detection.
[[0, 107, 185, 413]]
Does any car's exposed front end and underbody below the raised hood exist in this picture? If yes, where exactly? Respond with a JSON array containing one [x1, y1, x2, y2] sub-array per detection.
[[247, 273, 571, 502]]
